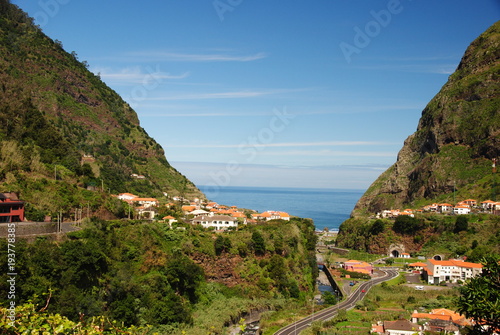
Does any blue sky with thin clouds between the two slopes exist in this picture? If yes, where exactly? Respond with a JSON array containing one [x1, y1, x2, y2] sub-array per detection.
[[12, 0, 500, 189]]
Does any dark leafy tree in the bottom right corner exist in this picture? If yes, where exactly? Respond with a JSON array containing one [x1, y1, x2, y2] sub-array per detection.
[[457, 256, 500, 334]]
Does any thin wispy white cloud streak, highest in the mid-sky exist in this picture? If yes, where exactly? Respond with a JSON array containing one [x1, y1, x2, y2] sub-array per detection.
[[129, 51, 267, 62]]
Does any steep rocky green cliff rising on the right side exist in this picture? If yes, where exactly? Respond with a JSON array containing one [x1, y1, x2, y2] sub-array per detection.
[[353, 21, 500, 216]]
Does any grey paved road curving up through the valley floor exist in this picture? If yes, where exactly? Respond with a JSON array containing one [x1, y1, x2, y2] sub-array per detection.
[[274, 268, 399, 335]]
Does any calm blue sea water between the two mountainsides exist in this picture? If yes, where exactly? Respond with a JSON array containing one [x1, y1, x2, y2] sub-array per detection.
[[199, 186, 364, 230]]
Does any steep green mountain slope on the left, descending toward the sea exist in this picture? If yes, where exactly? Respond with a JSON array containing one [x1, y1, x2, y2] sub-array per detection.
[[0, 0, 203, 218]]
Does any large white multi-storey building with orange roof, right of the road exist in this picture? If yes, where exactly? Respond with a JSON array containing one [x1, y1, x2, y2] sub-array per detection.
[[424, 259, 483, 285]]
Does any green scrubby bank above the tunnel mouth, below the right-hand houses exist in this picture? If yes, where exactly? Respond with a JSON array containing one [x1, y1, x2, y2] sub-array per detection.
[[337, 214, 500, 262]]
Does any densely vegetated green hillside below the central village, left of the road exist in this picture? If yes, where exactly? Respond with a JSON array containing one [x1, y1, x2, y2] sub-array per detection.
[[0, 219, 318, 334]]
